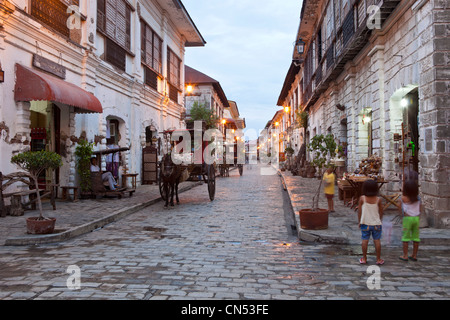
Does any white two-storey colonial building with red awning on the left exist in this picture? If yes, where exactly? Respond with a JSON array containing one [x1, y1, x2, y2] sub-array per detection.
[[0, 0, 205, 185]]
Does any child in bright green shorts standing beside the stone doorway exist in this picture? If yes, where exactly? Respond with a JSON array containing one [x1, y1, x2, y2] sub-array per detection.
[[399, 180, 422, 261]]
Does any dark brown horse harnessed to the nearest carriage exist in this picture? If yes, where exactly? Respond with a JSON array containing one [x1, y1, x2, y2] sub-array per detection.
[[161, 154, 187, 208]]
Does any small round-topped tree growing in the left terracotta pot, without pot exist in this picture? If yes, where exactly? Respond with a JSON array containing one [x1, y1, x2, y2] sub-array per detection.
[[11, 151, 62, 220]]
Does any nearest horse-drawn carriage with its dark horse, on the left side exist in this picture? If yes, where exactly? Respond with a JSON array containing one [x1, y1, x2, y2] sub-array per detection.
[[158, 124, 216, 206]]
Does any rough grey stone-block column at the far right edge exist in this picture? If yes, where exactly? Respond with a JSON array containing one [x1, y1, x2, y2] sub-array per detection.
[[419, 0, 450, 228]]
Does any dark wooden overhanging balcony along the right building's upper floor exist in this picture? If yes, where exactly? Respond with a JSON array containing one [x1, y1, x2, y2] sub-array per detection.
[[302, 0, 401, 108]]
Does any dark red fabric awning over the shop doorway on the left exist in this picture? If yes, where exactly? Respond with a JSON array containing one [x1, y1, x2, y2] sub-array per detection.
[[14, 63, 103, 113]]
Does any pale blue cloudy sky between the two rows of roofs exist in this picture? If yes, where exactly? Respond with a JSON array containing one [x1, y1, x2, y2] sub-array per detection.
[[182, 0, 302, 132]]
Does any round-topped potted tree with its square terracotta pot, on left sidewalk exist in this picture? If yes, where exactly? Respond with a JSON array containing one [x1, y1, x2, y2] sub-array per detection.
[[11, 151, 62, 234]]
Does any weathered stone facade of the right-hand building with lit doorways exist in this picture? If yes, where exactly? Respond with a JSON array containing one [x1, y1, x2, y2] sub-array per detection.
[[280, 0, 450, 228]]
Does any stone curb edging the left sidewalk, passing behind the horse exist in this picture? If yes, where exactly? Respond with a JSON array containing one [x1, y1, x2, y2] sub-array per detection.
[[4, 181, 202, 246]]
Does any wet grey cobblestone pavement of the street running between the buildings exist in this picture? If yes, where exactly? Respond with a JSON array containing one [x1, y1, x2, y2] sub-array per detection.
[[0, 166, 450, 300]]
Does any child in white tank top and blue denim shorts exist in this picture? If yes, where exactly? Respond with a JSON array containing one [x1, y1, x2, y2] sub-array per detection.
[[358, 180, 384, 265]]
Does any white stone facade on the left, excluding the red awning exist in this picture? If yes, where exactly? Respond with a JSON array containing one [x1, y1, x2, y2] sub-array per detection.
[[0, 0, 205, 189]]
